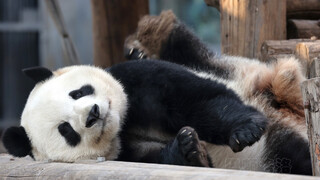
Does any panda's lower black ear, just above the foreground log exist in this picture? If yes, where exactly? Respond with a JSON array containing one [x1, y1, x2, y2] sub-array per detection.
[[2, 126, 31, 157]]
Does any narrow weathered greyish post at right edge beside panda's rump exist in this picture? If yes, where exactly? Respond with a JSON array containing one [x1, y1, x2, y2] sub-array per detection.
[[301, 59, 320, 176]]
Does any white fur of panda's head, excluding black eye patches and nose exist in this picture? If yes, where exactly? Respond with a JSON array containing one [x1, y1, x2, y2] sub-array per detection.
[[21, 66, 127, 162]]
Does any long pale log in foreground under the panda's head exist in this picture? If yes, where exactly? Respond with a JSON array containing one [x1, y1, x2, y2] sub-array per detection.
[[0, 154, 317, 180]]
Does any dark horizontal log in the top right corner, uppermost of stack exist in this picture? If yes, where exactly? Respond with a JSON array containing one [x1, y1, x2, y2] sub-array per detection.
[[287, 0, 320, 20]]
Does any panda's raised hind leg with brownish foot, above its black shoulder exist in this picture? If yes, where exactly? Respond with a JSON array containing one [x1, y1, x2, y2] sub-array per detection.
[[124, 11, 218, 73]]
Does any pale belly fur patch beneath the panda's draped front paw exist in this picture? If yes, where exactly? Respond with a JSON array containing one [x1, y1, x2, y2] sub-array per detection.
[[207, 136, 266, 171]]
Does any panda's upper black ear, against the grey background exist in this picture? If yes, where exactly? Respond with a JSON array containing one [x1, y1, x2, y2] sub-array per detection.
[[22, 66, 53, 83]]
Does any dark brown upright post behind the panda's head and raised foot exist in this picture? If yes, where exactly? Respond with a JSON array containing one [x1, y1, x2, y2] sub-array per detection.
[[91, 0, 149, 68]]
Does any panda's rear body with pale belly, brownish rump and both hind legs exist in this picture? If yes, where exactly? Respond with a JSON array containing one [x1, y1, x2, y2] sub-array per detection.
[[125, 11, 311, 174]]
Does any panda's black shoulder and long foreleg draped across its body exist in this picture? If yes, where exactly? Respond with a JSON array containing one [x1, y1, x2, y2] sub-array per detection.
[[108, 60, 267, 161]]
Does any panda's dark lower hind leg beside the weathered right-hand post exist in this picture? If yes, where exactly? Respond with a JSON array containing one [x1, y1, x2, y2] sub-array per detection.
[[265, 124, 312, 175]]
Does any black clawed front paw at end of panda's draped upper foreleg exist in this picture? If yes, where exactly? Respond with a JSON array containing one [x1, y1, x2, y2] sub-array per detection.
[[229, 114, 268, 152]]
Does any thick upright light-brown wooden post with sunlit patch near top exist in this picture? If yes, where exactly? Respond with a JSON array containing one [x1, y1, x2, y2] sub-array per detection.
[[220, 0, 286, 58]]
